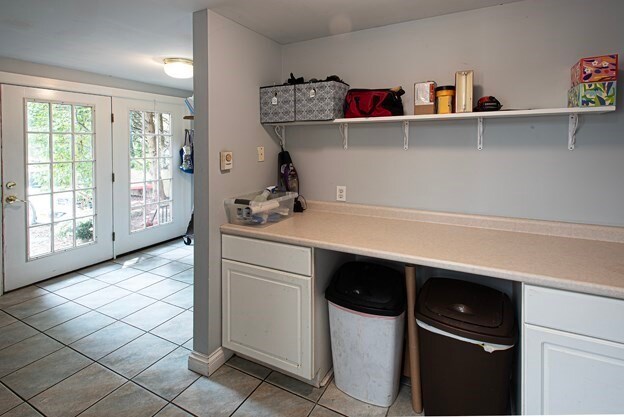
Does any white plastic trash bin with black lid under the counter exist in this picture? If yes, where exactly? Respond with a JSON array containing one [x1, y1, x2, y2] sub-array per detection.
[[325, 262, 405, 407]]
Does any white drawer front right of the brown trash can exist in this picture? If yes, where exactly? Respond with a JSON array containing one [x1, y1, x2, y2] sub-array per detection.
[[524, 285, 624, 343]]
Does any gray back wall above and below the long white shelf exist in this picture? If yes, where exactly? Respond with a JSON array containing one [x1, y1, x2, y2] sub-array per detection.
[[282, 0, 624, 226]]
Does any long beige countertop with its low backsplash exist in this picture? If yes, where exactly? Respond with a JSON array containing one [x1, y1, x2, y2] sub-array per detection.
[[221, 202, 624, 299]]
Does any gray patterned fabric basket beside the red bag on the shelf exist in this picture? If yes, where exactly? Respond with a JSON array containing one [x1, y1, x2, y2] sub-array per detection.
[[295, 81, 349, 121]]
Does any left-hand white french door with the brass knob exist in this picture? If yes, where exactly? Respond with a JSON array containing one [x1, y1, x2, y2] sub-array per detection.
[[1, 85, 113, 291]]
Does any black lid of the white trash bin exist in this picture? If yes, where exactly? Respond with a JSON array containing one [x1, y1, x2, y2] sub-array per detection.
[[325, 262, 405, 317]]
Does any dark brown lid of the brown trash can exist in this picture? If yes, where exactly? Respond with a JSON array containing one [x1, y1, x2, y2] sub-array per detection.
[[416, 278, 517, 345]]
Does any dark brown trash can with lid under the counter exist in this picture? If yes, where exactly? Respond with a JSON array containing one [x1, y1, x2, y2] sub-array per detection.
[[415, 278, 518, 416]]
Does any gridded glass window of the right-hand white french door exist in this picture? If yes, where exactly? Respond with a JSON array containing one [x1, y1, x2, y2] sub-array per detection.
[[128, 110, 173, 232]]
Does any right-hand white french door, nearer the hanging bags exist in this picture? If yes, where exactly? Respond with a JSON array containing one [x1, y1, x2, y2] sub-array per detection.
[[113, 98, 192, 255]]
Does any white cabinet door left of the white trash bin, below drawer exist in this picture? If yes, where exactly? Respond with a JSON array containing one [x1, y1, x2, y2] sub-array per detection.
[[223, 260, 314, 379]]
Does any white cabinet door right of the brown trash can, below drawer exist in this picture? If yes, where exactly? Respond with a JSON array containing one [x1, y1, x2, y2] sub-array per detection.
[[524, 325, 624, 414]]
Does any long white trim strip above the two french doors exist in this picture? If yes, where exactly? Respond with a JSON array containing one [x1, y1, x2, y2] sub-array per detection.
[[0, 71, 183, 104]]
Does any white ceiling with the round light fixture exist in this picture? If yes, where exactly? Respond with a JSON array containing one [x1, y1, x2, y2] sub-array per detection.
[[0, 0, 518, 90]]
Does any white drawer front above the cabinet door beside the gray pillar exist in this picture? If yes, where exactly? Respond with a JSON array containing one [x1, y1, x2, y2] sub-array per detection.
[[221, 235, 312, 276]]
